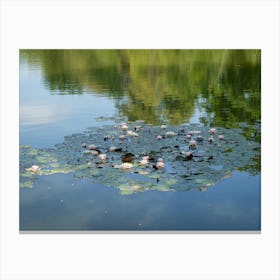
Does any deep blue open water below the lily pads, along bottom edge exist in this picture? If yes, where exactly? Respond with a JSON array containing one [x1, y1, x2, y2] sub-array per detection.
[[20, 173, 261, 230]]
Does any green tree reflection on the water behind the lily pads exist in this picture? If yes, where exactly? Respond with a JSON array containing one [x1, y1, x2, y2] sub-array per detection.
[[20, 50, 261, 127]]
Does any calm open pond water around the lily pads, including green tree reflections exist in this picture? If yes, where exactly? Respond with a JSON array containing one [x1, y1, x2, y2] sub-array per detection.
[[19, 50, 261, 230]]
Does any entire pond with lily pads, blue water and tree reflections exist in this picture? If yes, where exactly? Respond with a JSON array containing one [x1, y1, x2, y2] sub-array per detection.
[[19, 50, 261, 232]]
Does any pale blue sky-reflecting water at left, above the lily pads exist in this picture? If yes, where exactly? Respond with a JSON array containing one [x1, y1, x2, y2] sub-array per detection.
[[19, 63, 116, 148]]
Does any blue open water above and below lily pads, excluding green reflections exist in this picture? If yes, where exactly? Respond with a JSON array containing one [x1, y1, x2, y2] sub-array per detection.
[[19, 53, 261, 231]]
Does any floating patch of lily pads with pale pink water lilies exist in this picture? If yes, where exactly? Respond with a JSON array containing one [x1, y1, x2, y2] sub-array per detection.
[[20, 118, 260, 195]]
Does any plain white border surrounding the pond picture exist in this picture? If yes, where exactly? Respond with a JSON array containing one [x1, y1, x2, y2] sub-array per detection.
[[0, 0, 280, 280]]
